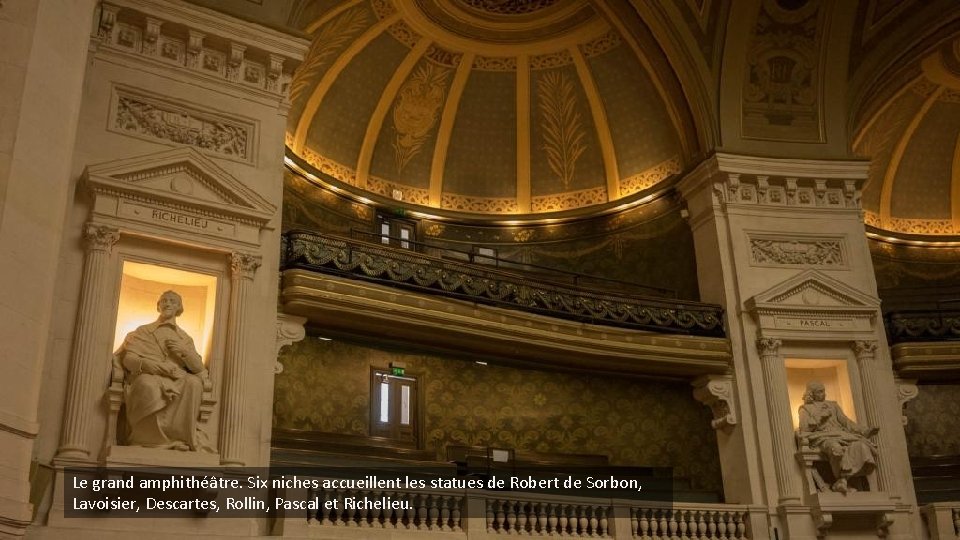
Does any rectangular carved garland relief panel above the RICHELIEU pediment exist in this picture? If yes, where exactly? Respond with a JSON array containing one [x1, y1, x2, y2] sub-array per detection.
[[108, 88, 257, 164]]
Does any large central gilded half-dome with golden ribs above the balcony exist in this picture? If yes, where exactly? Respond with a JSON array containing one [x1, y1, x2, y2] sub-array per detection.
[[287, 0, 696, 215]]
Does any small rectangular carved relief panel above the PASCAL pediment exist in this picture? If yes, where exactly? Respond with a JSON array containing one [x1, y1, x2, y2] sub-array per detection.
[[749, 234, 846, 268]]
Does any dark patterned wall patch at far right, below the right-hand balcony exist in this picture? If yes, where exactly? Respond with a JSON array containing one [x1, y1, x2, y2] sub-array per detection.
[[906, 384, 960, 457]]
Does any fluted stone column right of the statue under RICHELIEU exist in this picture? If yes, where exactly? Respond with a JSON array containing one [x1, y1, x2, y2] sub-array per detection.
[[220, 252, 261, 466]]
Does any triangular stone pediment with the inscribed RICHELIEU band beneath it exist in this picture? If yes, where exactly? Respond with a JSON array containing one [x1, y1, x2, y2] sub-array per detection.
[[82, 148, 276, 248]]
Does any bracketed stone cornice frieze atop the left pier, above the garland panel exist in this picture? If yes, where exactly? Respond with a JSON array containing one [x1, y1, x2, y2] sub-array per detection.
[[94, 0, 307, 97]]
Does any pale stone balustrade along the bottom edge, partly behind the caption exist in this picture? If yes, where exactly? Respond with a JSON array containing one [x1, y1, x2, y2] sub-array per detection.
[[274, 480, 752, 540]]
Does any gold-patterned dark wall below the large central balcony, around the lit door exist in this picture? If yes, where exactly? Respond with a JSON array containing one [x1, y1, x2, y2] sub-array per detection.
[[273, 337, 721, 491]]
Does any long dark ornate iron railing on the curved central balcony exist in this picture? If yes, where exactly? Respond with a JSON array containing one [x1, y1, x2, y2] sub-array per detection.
[[281, 231, 724, 337]]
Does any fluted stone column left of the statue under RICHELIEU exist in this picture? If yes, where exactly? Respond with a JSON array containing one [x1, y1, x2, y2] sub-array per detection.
[[57, 223, 120, 460]]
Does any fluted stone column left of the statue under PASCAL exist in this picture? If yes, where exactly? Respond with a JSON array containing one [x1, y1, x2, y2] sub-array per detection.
[[757, 338, 800, 503]]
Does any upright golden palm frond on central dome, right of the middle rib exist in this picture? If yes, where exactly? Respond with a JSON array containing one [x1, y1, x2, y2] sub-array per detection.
[[537, 71, 587, 189]]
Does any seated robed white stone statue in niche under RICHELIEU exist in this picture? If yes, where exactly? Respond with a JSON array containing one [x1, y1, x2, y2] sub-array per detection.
[[115, 291, 214, 452]]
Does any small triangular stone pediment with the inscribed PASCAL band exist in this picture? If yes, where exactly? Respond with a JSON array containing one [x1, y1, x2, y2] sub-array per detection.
[[745, 270, 880, 339]]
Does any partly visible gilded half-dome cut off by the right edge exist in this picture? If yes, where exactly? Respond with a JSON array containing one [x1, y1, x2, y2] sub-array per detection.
[[853, 39, 960, 236]]
